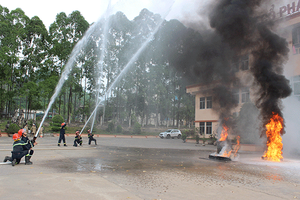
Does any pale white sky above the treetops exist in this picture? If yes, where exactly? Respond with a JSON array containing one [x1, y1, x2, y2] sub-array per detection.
[[0, 0, 207, 29]]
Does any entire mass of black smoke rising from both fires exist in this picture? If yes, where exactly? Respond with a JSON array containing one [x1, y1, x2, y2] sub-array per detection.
[[178, 0, 291, 134]]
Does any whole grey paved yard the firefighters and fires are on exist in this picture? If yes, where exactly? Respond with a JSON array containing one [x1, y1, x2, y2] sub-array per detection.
[[0, 137, 300, 200]]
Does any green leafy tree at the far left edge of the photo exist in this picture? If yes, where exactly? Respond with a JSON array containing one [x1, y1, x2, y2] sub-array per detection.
[[0, 6, 29, 113]]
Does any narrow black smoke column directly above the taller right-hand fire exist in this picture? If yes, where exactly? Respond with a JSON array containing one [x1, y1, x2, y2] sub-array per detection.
[[251, 26, 292, 134]]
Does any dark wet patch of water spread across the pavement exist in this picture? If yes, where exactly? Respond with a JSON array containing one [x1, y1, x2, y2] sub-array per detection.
[[42, 147, 300, 184]]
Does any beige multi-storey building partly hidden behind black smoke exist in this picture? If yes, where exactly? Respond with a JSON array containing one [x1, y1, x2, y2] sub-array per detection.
[[186, 0, 300, 137]]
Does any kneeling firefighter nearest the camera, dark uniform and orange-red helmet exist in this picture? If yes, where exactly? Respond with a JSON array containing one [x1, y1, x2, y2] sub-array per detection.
[[3, 133, 32, 166]]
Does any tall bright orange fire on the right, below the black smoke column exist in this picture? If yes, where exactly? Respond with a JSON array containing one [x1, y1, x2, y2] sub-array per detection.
[[262, 113, 283, 162]]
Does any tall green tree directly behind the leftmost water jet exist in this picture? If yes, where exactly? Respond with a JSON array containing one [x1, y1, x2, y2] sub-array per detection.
[[49, 11, 89, 121]]
